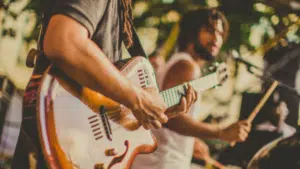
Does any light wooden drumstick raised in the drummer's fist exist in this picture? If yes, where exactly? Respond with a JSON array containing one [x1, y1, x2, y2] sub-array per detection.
[[230, 80, 278, 147]]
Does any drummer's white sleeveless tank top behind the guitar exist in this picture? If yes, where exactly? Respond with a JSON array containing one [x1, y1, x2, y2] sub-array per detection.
[[131, 53, 200, 169]]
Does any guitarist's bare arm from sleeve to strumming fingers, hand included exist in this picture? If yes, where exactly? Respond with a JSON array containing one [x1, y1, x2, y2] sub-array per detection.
[[43, 15, 167, 128]]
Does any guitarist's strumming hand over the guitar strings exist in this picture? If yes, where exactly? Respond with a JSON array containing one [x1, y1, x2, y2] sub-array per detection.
[[131, 88, 168, 130]]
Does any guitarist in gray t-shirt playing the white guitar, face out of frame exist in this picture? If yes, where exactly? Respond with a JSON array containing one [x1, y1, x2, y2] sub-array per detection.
[[11, 0, 196, 169]]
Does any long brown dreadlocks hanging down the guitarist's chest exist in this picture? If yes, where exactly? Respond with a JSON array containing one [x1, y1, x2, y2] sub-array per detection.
[[121, 0, 133, 47]]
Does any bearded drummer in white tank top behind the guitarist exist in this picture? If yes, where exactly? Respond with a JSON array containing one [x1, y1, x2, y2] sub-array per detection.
[[132, 9, 250, 169]]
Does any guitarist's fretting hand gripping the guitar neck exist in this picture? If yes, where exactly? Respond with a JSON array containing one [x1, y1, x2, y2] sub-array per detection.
[[165, 84, 198, 118]]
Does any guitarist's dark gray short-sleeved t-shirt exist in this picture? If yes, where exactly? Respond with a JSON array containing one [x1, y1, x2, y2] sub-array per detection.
[[44, 0, 123, 62]]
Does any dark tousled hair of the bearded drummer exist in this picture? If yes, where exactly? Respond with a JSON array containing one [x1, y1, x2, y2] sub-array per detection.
[[178, 8, 229, 51]]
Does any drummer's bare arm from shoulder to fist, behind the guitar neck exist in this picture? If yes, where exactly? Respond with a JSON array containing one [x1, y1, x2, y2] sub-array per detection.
[[163, 61, 250, 141]]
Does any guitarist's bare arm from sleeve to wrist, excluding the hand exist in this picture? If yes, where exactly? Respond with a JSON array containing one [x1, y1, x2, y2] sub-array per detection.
[[44, 15, 141, 108]]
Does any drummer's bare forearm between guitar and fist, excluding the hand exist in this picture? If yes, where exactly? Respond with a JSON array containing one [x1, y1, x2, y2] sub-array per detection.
[[165, 114, 221, 139]]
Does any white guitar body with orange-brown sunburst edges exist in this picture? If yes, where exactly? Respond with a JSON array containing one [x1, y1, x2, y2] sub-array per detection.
[[37, 57, 157, 169]]
